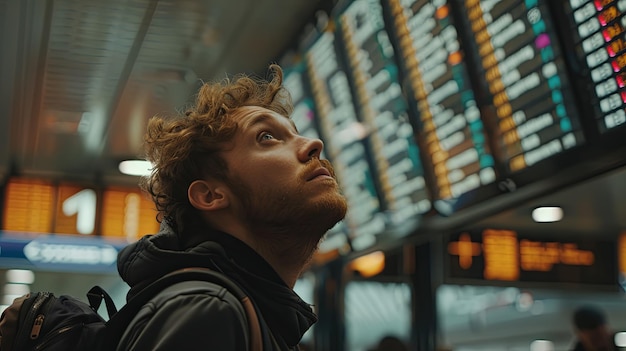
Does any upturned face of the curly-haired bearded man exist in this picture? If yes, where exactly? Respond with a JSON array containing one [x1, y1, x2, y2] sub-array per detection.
[[222, 106, 347, 237]]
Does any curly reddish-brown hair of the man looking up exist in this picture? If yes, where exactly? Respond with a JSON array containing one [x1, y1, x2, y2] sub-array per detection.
[[140, 64, 293, 233]]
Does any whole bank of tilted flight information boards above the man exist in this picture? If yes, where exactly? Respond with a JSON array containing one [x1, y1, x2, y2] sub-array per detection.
[[282, 0, 626, 248]]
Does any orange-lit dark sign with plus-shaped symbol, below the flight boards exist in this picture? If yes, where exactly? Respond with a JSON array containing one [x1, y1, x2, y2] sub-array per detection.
[[446, 229, 617, 286]]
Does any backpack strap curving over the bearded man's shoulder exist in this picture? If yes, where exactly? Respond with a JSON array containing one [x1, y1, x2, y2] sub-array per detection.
[[104, 267, 263, 351]]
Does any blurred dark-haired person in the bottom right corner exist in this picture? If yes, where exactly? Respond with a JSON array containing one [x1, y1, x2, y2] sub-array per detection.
[[572, 306, 618, 351]]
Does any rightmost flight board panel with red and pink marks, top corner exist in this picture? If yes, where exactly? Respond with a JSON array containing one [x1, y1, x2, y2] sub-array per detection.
[[568, 0, 626, 134]]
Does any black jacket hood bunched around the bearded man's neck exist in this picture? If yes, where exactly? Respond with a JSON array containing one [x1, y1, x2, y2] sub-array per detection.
[[118, 224, 317, 347]]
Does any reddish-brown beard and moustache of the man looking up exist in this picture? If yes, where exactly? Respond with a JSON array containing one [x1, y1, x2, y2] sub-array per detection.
[[228, 159, 348, 242]]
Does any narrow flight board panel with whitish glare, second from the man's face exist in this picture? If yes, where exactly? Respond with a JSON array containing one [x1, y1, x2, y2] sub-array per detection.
[[304, 30, 386, 247]]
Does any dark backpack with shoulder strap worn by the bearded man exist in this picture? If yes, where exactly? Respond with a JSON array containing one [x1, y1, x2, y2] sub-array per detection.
[[0, 268, 263, 351]]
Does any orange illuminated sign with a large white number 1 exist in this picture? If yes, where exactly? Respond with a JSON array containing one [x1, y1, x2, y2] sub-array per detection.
[[0, 178, 159, 241]]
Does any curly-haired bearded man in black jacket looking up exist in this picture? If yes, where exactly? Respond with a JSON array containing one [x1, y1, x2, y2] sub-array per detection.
[[118, 65, 347, 351]]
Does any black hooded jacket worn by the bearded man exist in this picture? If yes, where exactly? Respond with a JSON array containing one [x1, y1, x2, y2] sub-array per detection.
[[118, 225, 317, 351]]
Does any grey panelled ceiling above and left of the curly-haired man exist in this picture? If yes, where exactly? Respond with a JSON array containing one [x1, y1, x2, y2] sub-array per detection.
[[0, 0, 321, 185]]
